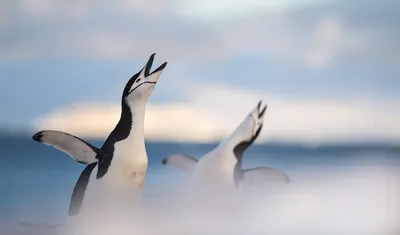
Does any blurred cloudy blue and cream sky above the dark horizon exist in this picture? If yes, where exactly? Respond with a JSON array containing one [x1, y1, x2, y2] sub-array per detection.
[[0, 0, 400, 144]]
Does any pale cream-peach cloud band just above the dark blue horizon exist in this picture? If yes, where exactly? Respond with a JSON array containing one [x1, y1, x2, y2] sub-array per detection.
[[33, 83, 400, 144]]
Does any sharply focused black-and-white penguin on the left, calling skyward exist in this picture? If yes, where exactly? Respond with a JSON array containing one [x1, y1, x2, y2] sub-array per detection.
[[32, 53, 167, 218]]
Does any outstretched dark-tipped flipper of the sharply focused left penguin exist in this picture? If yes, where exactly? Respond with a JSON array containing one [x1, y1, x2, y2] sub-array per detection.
[[32, 130, 106, 165]]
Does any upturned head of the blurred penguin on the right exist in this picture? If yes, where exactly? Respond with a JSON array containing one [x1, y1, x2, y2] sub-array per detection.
[[231, 101, 267, 151]]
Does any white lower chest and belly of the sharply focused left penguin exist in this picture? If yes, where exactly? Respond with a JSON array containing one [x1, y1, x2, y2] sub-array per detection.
[[78, 141, 147, 215]]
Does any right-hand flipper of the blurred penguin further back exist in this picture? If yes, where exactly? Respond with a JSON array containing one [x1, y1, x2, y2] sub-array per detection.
[[242, 167, 290, 185]]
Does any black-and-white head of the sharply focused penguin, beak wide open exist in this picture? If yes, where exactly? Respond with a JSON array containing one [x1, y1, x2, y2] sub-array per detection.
[[122, 53, 167, 103]]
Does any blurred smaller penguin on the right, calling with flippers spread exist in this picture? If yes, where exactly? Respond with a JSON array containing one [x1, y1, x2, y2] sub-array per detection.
[[162, 101, 290, 194]]
